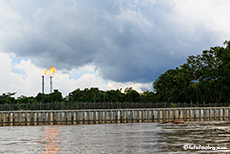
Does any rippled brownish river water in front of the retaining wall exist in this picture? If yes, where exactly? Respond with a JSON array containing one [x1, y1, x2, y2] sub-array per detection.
[[0, 121, 230, 154]]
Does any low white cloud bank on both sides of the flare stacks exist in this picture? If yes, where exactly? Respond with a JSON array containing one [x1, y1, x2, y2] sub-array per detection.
[[0, 52, 151, 97]]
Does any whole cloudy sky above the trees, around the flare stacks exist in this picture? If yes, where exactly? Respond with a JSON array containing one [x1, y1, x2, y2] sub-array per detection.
[[0, 0, 230, 97]]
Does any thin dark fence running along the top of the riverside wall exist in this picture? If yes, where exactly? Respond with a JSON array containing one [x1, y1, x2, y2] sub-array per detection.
[[0, 102, 230, 111]]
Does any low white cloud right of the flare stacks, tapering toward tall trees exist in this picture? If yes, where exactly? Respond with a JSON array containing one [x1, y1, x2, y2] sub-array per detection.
[[53, 65, 152, 95]]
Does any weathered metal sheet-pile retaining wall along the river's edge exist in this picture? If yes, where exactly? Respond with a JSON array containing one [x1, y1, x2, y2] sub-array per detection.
[[0, 107, 230, 126]]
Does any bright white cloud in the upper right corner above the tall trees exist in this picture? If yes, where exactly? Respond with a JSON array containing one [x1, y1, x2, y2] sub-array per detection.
[[174, 0, 230, 45]]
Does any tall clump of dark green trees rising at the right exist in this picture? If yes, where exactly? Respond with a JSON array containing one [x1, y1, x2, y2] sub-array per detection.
[[153, 41, 230, 103]]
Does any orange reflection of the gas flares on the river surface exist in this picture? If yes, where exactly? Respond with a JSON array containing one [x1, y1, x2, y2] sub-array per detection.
[[41, 126, 62, 154]]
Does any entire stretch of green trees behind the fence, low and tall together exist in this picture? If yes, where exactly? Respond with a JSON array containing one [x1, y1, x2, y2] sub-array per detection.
[[0, 41, 230, 104]]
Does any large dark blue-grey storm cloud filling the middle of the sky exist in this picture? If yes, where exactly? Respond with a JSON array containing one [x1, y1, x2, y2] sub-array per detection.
[[1, 0, 219, 82]]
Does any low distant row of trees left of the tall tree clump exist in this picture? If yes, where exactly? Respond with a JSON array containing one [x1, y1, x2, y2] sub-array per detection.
[[0, 87, 156, 104]]
